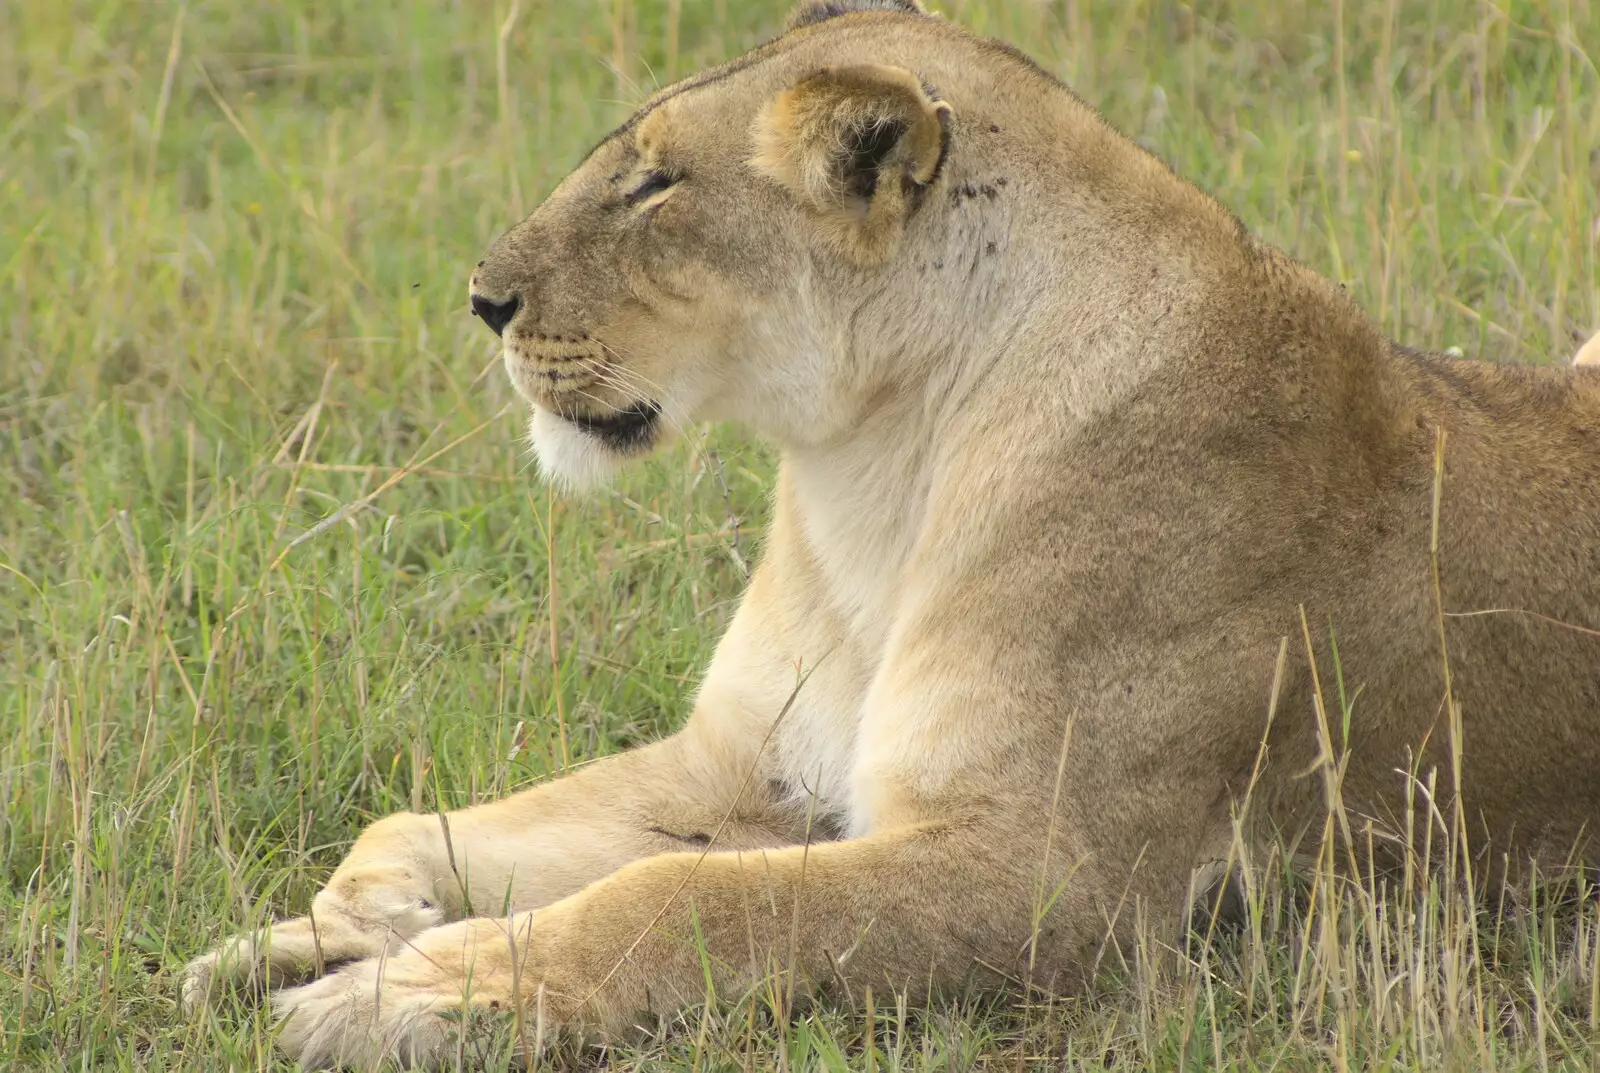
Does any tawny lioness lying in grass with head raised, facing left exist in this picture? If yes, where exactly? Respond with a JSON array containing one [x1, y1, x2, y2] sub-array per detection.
[[186, 0, 1600, 1065]]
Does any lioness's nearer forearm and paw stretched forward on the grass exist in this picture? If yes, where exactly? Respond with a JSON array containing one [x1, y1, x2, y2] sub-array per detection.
[[277, 825, 1070, 1068]]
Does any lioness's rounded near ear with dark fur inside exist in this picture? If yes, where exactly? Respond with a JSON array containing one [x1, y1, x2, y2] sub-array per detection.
[[752, 64, 952, 261]]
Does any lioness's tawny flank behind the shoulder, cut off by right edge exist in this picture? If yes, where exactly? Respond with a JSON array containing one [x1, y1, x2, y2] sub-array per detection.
[[1376, 352, 1600, 848]]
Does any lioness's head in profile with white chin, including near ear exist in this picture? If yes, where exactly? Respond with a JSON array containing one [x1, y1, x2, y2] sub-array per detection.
[[472, 5, 950, 485]]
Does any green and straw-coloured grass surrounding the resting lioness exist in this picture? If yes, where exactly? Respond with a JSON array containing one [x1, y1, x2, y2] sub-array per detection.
[[0, 0, 1600, 1070]]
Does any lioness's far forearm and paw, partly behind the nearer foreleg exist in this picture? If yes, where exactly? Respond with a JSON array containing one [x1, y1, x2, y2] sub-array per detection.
[[182, 731, 803, 1006]]
